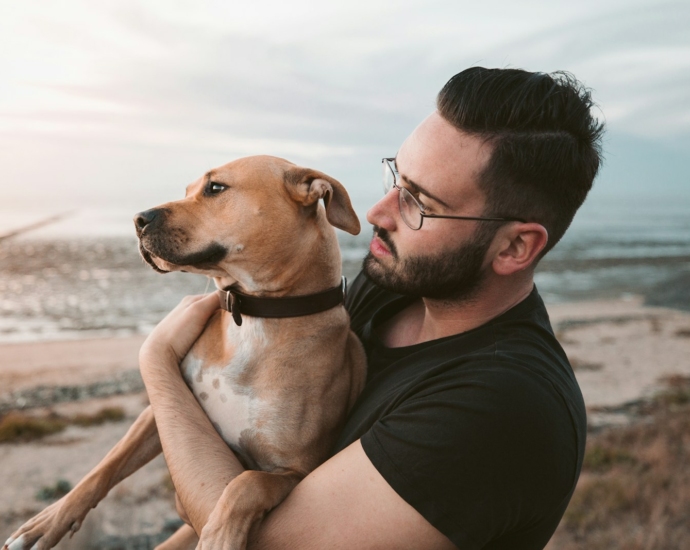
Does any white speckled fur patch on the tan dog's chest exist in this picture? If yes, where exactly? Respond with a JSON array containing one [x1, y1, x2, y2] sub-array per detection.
[[181, 319, 272, 449]]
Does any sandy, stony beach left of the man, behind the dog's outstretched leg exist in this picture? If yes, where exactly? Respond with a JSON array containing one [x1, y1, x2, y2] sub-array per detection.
[[0, 336, 179, 549]]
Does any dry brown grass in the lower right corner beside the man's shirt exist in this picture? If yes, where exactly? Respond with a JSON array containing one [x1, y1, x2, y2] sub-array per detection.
[[548, 377, 690, 550]]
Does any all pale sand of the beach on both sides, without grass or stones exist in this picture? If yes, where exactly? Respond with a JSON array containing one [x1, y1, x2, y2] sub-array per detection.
[[0, 298, 690, 548]]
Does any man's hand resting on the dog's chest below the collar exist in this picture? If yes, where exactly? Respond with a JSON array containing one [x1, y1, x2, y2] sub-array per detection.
[[139, 292, 220, 371]]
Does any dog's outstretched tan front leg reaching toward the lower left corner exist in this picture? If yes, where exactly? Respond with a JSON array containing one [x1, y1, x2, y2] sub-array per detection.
[[3, 407, 161, 550]]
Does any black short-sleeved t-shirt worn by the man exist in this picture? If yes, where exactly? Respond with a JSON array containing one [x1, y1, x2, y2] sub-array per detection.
[[336, 274, 587, 550]]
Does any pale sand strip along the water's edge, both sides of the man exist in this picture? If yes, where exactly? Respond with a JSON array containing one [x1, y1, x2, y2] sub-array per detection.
[[0, 296, 690, 416]]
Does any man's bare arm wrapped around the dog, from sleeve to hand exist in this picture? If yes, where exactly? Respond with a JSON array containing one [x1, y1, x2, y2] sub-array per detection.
[[140, 295, 455, 550]]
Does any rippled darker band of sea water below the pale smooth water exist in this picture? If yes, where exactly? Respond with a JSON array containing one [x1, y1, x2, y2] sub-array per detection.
[[0, 235, 690, 350]]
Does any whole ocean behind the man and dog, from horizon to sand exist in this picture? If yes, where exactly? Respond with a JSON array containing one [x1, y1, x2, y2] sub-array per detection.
[[0, 196, 690, 343]]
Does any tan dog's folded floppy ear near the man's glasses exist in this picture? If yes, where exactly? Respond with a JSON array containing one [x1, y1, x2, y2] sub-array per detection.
[[284, 167, 360, 235]]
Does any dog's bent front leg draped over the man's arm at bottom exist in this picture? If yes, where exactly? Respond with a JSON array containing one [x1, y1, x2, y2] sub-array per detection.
[[197, 470, 304, 550]]
